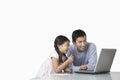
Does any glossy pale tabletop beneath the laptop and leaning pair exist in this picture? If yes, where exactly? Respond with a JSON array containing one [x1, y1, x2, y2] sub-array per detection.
[[31, 72, 120, 80]]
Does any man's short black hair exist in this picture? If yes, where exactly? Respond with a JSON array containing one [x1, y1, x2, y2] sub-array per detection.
[[72, 29, 86, 42]]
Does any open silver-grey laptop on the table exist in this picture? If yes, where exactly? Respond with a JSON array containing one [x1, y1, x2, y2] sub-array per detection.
[[75, 48, 116, 74]]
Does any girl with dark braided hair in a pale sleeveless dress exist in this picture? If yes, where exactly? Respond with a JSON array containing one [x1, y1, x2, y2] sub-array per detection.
[[37, 35, 73, 77]]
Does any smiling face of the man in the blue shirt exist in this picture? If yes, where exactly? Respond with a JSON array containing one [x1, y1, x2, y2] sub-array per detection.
[[73, 36, 87, 51]]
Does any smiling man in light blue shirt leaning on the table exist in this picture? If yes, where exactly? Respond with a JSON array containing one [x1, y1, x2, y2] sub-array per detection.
[[67, 29, 97, 71]]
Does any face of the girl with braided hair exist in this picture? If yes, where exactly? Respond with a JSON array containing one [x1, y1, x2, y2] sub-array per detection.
[[58, 41, 70, 54]]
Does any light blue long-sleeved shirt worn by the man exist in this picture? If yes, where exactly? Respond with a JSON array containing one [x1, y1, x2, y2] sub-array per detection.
[[67, 43, 97, 71]]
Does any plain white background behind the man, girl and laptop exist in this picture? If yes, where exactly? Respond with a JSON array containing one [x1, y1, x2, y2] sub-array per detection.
[[0, 0, 120, 80]]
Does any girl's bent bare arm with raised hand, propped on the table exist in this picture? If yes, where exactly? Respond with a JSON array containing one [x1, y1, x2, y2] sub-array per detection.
[[52, 56, 73, 73]]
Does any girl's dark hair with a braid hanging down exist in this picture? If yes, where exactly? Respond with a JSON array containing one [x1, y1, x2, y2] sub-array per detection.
[[54, 35, 70, 63]]
